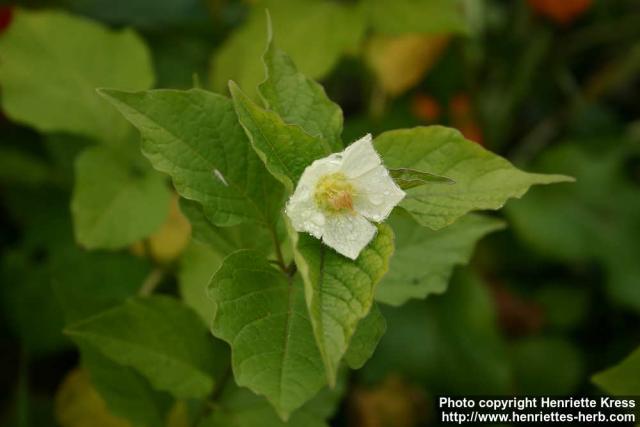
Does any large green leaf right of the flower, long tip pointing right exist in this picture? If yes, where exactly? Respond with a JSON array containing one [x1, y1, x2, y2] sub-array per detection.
[[374, 126, 573, 230]]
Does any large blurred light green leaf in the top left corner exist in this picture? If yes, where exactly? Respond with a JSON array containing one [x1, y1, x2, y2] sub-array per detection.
[[0, 10, 153, 141]]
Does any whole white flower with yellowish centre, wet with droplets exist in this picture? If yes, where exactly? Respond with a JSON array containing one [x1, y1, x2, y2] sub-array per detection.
[[286, 134, 405, 259]]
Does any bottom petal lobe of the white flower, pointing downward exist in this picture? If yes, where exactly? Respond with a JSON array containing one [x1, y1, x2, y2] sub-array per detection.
[[322, 215, 378, 259]]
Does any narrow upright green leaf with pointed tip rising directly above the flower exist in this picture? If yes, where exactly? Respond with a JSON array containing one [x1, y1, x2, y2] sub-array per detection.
[[259, 28, 343, 151]]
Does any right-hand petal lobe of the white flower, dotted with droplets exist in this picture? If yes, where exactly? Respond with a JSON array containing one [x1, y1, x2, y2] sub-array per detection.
[[352, 166, 405, 222]]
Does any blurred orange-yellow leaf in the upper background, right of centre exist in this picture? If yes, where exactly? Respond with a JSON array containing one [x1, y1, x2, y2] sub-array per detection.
[[365, 34, 449, 96]]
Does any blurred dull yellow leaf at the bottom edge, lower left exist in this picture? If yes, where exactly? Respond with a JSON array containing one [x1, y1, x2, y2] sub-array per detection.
[[55, 368, 132, 427]]
